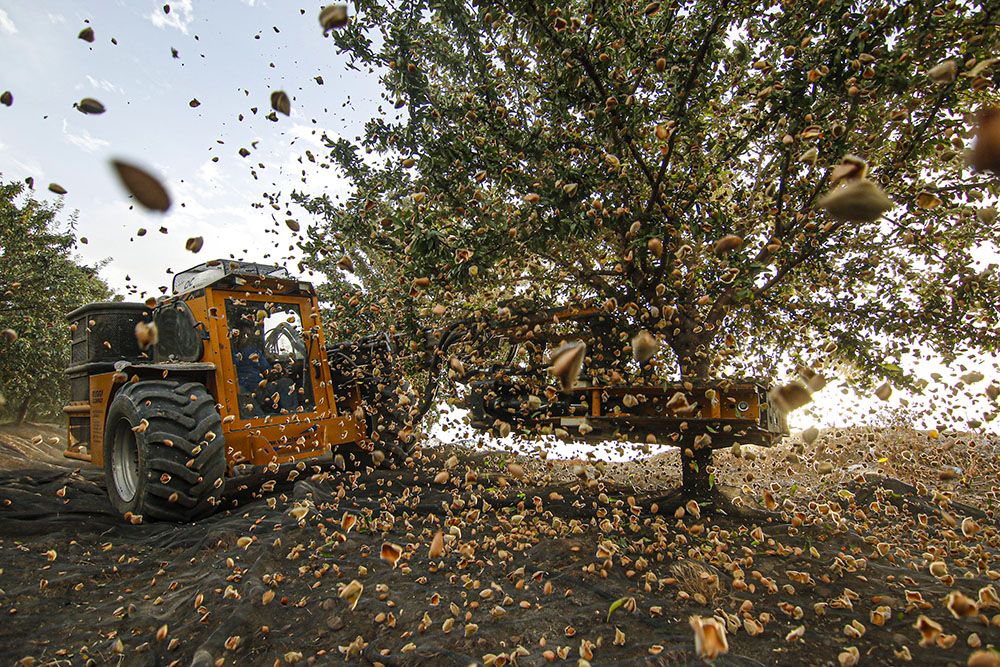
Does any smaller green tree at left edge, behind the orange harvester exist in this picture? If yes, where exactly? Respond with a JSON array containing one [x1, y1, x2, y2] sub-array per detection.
[[0, 182, 111, 419]]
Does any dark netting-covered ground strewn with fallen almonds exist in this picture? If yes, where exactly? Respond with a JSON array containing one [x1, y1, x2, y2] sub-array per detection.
[[0, 426, 1000, 667]]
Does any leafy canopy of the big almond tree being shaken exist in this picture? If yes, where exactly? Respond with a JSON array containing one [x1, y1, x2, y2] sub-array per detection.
[[299, 0, 1000, 396]]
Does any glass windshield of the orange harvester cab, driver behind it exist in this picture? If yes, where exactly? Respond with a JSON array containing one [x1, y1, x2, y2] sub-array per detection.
[[226, 299, 315, 419]]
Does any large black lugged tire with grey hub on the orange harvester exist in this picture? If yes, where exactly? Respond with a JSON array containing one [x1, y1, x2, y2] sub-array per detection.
[[104, 380, 226, 522]]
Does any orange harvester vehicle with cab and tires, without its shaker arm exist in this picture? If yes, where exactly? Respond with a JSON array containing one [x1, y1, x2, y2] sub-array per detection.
[[65, 260, 412, 521]]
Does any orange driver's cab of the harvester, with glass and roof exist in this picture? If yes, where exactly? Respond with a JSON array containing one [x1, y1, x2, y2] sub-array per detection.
[[153, 260, 359, 465]]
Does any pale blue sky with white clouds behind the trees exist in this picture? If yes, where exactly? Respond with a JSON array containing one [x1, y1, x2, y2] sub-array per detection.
[[0, 0, 1000, 438]]
